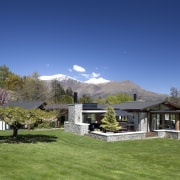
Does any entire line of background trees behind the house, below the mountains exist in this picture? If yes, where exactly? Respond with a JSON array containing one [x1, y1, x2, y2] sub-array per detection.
[[0, 65, 180, 105]]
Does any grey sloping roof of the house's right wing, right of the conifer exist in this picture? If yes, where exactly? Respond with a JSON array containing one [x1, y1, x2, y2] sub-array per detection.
[[113, 101, 164, 111]]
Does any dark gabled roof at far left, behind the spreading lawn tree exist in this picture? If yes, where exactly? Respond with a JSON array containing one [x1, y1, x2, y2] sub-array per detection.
[[3, 101, 46, 109]]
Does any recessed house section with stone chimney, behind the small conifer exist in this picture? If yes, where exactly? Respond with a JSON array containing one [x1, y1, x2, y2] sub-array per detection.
[[64, 103, 134, 135]]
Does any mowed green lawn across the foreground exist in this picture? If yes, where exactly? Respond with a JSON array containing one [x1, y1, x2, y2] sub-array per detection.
[[0, 130, 180, 180]]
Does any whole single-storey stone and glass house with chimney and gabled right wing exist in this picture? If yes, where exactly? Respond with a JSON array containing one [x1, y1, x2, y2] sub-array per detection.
[[64, 101, 180, 134]]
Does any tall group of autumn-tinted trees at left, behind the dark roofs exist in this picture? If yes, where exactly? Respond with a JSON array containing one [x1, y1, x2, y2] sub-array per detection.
[[0, 65, 73, 104]]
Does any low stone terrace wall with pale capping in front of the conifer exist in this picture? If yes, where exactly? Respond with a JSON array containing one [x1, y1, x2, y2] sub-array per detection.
[[90, 131, 146, 142]]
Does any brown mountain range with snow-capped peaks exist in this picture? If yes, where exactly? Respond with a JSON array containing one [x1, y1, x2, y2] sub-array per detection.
[[39, 74, 168, 101]]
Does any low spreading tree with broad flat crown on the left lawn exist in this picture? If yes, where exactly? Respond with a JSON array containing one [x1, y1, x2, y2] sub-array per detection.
[[0, 107, 57, 137]]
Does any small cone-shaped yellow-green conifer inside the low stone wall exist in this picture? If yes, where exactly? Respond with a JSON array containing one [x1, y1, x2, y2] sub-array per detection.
[[100, 105, 121, 132]]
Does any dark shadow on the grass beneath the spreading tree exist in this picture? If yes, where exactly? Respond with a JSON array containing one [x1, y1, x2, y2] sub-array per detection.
[[0, 134, 57, 144]]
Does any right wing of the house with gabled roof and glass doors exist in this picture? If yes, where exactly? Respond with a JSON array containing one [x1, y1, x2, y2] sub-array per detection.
[[114, 101, 180, 132]]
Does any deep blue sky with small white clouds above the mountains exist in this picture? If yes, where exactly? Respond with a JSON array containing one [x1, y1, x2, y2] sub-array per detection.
[[0, 0, 180, 94]]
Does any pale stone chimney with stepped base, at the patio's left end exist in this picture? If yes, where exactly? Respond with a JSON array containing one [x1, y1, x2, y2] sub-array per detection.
[[64, 104, 89, 135]]
